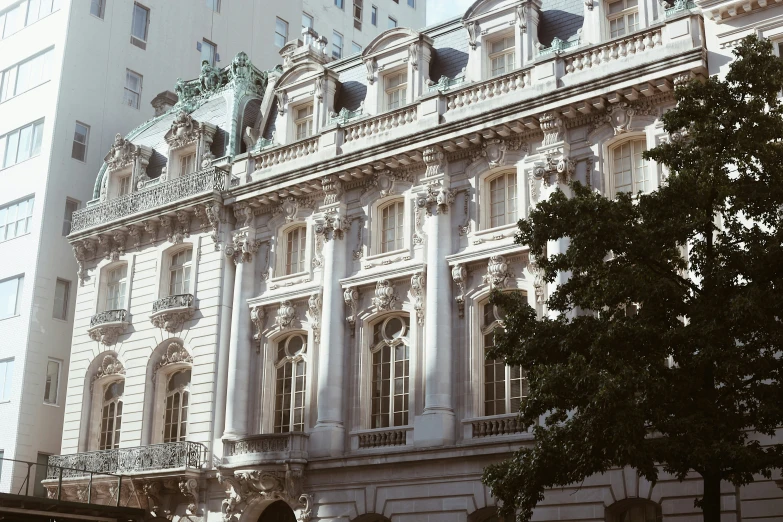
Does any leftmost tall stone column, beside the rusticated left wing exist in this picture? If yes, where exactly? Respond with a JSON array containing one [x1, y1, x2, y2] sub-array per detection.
[[223, 203, 259, 438]]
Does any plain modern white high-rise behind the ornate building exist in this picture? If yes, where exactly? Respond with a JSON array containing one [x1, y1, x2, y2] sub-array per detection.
[[0, 0, 425, 492]]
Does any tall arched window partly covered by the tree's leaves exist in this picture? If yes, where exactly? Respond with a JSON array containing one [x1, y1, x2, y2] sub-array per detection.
[[481, 296, 528, 416]]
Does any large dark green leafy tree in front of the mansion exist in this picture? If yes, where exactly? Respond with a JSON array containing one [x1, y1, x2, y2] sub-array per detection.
[[483, 37, 783, 522]]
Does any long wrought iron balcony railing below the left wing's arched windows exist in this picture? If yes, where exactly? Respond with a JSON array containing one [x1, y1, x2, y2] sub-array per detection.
[[46, 441, 207, 479]]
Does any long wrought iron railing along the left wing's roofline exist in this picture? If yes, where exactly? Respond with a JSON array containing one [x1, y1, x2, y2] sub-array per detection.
[[71, 167, 229, 233]]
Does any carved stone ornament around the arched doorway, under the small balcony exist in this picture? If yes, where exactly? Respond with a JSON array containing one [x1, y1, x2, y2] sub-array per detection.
[[217, 468, 313, 522]]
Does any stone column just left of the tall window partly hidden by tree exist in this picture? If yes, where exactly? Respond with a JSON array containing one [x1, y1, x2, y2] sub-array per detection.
[[413, 147, 456, 447]]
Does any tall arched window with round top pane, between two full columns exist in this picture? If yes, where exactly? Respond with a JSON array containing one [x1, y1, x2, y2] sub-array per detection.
[[371, 315, 410, 428]]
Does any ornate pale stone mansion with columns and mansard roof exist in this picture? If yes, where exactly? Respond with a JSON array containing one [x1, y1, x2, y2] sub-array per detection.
[[45, 0, 783, 522]]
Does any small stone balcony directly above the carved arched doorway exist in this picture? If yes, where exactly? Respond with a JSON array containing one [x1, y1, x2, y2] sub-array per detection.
[[223, 432, 309, 466]]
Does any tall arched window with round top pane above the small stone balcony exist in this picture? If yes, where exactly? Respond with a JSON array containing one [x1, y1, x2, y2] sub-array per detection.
[[274, 333, 307, 433]]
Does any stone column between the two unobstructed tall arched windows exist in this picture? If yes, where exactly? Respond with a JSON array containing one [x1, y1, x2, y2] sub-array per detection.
[[308, 176, 350, 457]]
